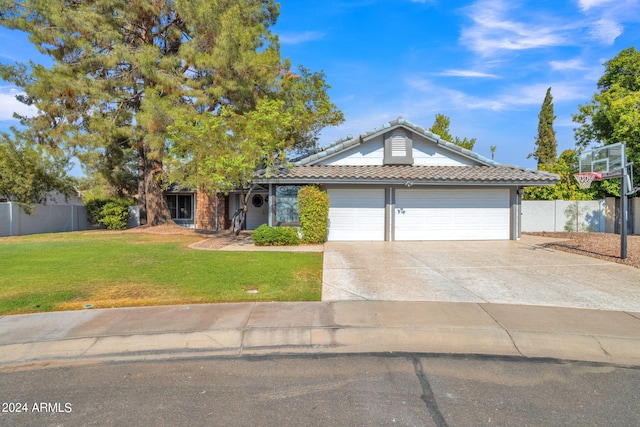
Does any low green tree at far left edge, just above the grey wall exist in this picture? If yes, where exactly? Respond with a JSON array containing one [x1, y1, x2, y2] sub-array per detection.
[[0, 130, 75, 213]]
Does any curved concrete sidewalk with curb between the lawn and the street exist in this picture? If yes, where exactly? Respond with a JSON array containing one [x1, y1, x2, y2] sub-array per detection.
[[0, 301, 640, 369]]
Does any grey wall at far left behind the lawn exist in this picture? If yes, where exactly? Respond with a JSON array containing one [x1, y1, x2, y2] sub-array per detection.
[[0, 202, 93, 237]]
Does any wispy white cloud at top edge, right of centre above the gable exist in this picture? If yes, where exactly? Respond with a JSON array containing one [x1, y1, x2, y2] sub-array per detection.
[[461, 0, 566, 56]]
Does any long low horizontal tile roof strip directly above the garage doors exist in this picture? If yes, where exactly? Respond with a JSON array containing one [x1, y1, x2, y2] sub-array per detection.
[[255, 165, 559, 185]]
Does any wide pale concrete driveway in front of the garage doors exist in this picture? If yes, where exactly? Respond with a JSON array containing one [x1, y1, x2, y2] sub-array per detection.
[[322, 236, 640, 311]]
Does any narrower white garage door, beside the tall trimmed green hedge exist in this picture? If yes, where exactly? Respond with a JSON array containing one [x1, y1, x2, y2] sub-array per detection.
[[327, 189, 384, 241]]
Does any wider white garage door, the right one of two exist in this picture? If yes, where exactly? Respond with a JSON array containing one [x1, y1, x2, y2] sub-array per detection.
[[395, 189, 510, 240]]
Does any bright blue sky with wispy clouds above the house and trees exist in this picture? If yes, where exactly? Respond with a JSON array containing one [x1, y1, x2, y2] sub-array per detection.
[[0, 0, 640, 168]]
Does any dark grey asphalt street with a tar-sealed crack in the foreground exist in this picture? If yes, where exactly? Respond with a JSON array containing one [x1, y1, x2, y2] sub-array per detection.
[[0, 353, 640, 426]]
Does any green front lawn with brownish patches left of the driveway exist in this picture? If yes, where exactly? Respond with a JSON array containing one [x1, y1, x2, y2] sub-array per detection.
[[0, 232, 322, 314]]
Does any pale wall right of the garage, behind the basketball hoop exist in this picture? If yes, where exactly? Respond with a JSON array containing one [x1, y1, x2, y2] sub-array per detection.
[[522, 200, 607, 232]]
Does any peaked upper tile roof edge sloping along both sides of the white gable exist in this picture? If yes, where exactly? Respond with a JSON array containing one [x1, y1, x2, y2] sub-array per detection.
[[291, 117, 498, 166]]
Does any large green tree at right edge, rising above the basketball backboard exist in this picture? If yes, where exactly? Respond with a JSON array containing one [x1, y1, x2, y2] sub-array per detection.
[[573, 47, 640, 178]]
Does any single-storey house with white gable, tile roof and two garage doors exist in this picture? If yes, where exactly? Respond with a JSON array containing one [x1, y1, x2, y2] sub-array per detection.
[[178, 117, 558, 241]]
